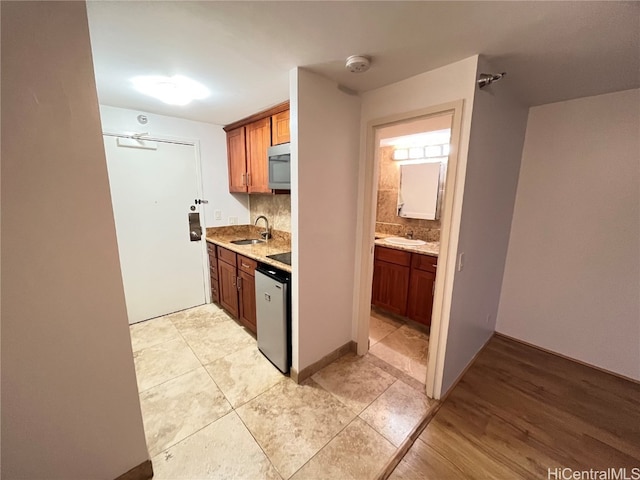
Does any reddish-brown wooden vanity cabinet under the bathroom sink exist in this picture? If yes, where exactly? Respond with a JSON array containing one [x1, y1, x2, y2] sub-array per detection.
[[371, 245, 438, 325]]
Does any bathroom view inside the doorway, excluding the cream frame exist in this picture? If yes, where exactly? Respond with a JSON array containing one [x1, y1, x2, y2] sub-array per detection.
[[369, 113, 453, 385]]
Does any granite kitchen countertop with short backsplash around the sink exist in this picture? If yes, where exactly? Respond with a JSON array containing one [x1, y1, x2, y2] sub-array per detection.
[[205, 225, 291, 273]]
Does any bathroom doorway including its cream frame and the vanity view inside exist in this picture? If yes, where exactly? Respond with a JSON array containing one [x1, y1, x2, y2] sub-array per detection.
[[356, 100, 463, 399]]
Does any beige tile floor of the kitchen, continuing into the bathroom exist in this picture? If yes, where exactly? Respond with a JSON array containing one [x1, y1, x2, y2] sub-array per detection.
[[131, 305, 435, 480]]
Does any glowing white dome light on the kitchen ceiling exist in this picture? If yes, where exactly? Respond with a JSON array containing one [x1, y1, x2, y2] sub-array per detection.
[[131, 75, 211, 105]]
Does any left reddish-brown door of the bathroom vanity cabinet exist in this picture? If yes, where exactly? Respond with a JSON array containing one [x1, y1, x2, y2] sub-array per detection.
[[371, 260, 409, 315]]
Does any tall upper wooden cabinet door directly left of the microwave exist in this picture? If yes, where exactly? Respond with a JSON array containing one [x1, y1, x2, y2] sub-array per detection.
[[245, 118, 272, 193]]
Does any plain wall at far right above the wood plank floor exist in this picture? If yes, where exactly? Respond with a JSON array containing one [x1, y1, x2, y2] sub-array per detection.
[[497, 89, 640, 380]]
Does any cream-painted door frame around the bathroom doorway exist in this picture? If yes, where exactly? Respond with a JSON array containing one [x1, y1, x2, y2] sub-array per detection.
[[354, 99, 464, 399]]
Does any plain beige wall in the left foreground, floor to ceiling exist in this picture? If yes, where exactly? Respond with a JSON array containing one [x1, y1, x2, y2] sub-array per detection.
[[1, 2, 149, 479]]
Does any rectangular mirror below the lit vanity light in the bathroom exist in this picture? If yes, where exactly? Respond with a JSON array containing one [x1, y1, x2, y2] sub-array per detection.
[[397, 162, 446, 220]]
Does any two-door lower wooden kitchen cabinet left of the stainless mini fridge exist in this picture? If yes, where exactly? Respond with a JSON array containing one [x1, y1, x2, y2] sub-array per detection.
[[217, 246, 258, 333]]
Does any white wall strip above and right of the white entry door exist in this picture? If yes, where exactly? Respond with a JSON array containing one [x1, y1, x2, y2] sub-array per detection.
[[100, 105, 249, 227]]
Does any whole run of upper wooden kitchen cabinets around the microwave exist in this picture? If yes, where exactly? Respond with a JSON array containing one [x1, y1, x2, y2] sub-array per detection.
[[224, 102, 290, 193]]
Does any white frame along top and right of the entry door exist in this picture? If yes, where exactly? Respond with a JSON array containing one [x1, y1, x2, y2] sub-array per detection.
[[102, 130, 212, 303]]
